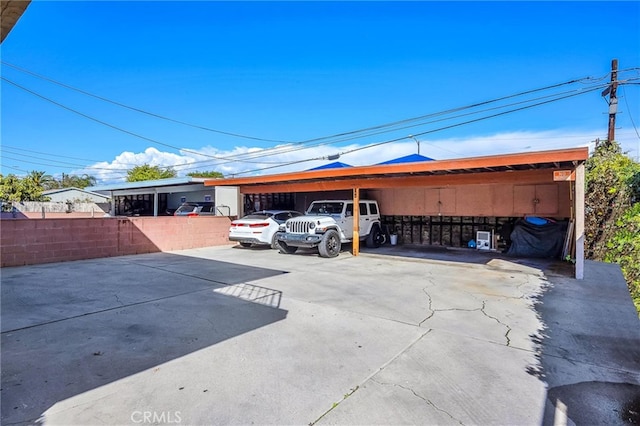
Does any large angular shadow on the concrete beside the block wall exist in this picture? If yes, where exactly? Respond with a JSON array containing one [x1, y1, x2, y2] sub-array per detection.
[[0, 253, 287, 424]]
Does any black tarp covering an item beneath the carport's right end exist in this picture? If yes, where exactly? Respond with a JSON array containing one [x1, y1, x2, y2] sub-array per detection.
[[507, 219, 567, 259]]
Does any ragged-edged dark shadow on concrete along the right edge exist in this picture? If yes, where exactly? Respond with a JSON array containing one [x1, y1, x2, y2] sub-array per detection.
[[529, 261, 640, 425]]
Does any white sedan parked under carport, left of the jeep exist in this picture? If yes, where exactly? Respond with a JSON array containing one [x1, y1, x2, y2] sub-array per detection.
[[229, 210, 302, 249]]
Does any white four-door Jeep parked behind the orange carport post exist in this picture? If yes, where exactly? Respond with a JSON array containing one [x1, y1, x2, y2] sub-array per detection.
[[277, 200, 386, 257]]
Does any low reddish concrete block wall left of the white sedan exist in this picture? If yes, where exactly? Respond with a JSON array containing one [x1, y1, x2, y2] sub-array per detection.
[[0, 216, 231, 267]]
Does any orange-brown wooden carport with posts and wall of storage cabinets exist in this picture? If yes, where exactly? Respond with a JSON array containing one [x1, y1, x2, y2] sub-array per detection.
[[205, 147, 589, 279]]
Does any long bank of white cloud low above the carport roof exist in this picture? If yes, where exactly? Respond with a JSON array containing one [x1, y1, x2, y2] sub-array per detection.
[[76, 130, 640, 183]]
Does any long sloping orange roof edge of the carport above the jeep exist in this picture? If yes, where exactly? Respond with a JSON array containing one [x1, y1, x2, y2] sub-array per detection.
[[205, 147, 589, 189]]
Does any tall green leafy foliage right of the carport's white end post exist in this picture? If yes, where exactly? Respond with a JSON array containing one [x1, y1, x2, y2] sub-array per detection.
[[585, 142, 640, 312]]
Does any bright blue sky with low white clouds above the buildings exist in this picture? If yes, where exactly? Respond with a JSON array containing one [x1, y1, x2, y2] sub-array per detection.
[[1, 0, 640, 183]]
